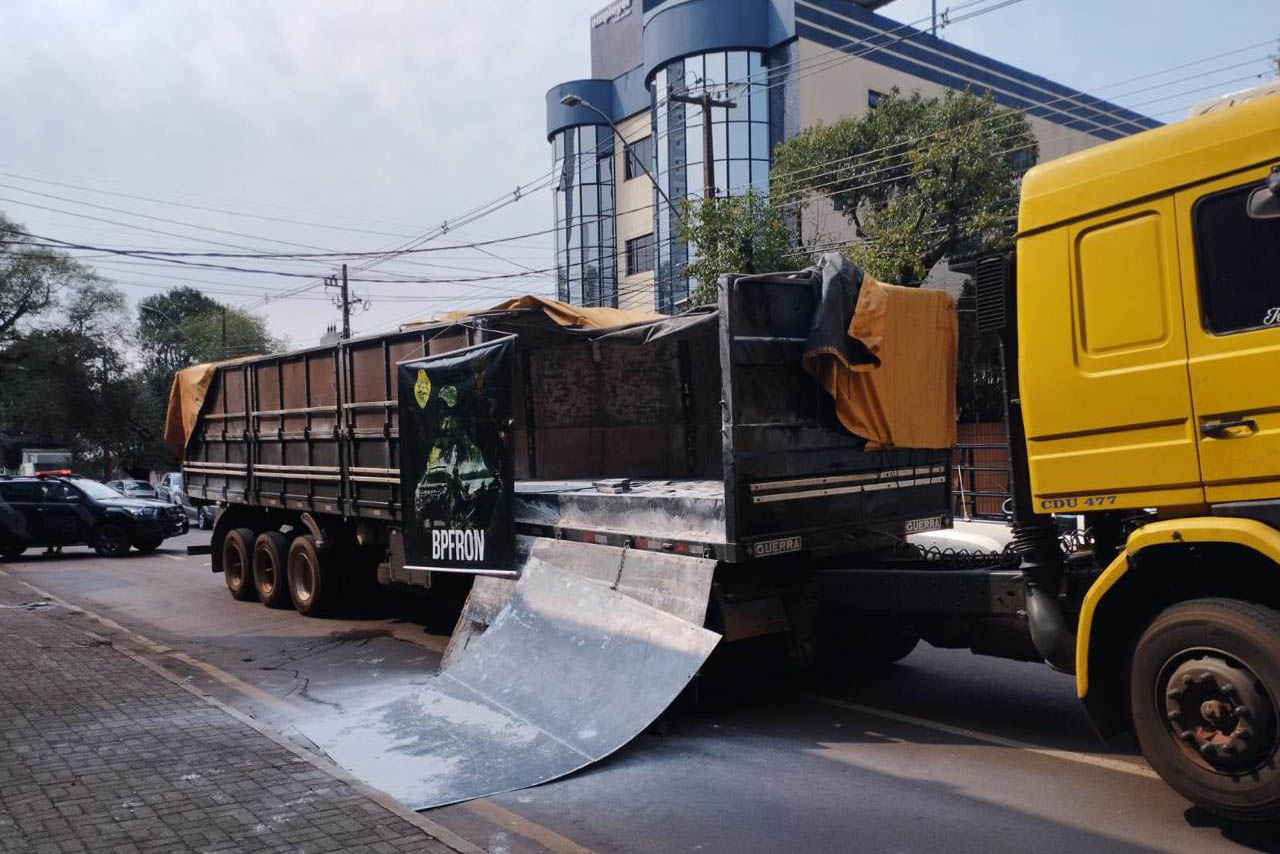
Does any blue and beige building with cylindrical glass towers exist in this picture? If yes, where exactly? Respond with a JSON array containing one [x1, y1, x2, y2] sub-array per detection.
[[547, 0, 1157, 312]]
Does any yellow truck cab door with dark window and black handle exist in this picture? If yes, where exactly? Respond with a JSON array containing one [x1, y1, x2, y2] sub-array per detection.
[[1178, 165, 1280, 504]]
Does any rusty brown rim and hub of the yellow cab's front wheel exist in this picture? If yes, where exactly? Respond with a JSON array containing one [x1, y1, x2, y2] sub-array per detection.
[[1156, 649, 1280, 776]]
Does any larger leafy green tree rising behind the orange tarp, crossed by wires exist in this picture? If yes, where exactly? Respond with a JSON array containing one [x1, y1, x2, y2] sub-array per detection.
[[772, 91, 1038, 284]]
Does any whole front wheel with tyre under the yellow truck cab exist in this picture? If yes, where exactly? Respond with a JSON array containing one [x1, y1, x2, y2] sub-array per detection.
[[1129, 599, 1280, 821]]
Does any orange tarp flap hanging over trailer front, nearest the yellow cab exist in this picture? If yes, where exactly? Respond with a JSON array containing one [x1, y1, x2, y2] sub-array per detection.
[[804, 275, 959, 448]]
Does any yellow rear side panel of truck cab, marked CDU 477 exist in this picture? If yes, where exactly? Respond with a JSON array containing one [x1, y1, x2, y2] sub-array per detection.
[[1018, 195, 1204, 513]]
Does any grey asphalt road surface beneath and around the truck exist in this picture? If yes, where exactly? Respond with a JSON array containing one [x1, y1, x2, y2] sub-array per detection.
[[0, 531, 1280, 854]]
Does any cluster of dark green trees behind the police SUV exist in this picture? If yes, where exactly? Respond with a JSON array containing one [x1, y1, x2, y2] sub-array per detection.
[[0, 216, 280, 476]]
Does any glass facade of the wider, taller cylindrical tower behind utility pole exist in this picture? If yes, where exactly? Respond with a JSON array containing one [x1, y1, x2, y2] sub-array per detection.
[[650, 50, 771, 314]]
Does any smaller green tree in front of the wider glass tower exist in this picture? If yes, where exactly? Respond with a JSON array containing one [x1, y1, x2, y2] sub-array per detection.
[[677, 191, 803, 306]]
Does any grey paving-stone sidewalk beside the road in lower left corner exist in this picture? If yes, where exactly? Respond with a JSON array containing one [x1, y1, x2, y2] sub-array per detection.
[[0, 576, 454, 854]]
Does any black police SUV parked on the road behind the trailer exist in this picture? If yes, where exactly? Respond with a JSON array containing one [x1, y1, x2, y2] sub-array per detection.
[[0, 472, 188, 558]]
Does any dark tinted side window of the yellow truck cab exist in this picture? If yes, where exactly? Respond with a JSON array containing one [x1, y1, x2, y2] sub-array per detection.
[[1194, 183, 1280, 335]]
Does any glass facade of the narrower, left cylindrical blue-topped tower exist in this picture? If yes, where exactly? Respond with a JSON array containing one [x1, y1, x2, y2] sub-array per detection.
[[552, 125, 618, 306]]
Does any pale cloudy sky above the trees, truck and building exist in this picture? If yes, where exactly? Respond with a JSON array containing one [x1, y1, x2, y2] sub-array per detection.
[[0, 0, 1280, 346]]
